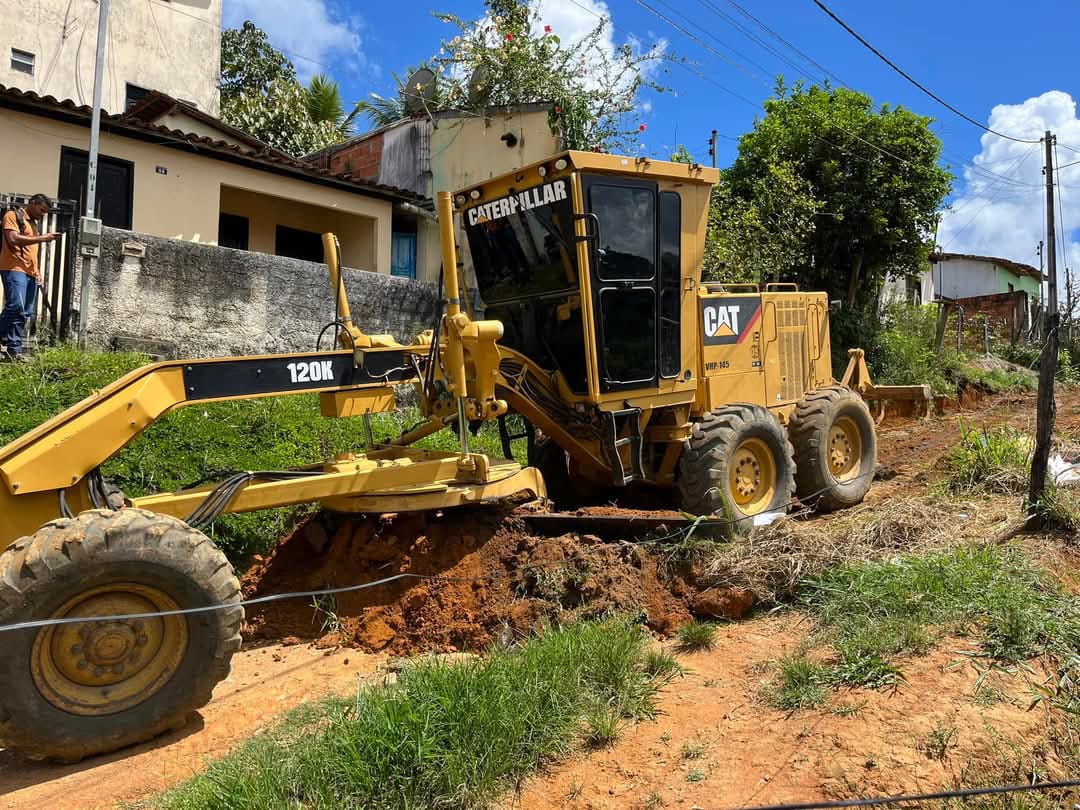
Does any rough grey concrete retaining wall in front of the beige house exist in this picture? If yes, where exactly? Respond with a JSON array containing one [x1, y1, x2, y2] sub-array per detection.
[[84, 228, 441, 356]]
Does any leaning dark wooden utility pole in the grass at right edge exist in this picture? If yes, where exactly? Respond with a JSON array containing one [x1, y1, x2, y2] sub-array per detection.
[[1027, 130, 1061, 525]]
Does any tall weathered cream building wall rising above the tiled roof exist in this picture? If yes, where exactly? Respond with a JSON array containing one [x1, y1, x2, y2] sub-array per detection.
[[0, 0, 221, 116]]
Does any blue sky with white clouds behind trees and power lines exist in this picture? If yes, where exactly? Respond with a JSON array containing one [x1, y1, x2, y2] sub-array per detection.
[[225, 0, 1080, 273]]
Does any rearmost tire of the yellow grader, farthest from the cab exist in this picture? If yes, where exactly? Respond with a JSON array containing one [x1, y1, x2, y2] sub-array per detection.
[[787, 386, 877, 512]]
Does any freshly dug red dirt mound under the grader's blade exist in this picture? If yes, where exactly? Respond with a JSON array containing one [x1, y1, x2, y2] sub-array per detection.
[[243, 508, 692, 653]]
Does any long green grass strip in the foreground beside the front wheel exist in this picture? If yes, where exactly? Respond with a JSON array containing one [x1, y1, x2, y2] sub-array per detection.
[[159, 619, 657, 810]]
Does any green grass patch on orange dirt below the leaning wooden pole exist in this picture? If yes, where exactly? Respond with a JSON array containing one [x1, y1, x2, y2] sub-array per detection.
[[774, 546, 1080, 703]]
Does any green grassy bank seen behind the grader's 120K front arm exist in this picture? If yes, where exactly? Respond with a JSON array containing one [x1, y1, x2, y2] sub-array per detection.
[[0, 347, 524, 564]]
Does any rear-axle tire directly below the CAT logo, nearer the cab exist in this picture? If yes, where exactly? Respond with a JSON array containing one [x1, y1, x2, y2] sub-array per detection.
[[678, 405, 795, 535]]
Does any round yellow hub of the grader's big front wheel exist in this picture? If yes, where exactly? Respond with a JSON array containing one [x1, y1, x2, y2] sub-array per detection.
[[31, 583, 188, 715]]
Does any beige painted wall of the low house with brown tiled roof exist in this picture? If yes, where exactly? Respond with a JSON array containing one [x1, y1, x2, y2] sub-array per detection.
[[0, 109, 392, 273]]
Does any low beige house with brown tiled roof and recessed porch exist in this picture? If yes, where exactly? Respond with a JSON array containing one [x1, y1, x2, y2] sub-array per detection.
[[0, 84, 424, 273]]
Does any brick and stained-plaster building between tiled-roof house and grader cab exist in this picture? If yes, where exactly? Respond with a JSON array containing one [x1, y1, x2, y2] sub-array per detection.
[[306, 104, 562, 284]]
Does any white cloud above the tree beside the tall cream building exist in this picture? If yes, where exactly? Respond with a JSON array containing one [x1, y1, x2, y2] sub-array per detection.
[[222, 0, 367, 81]]
